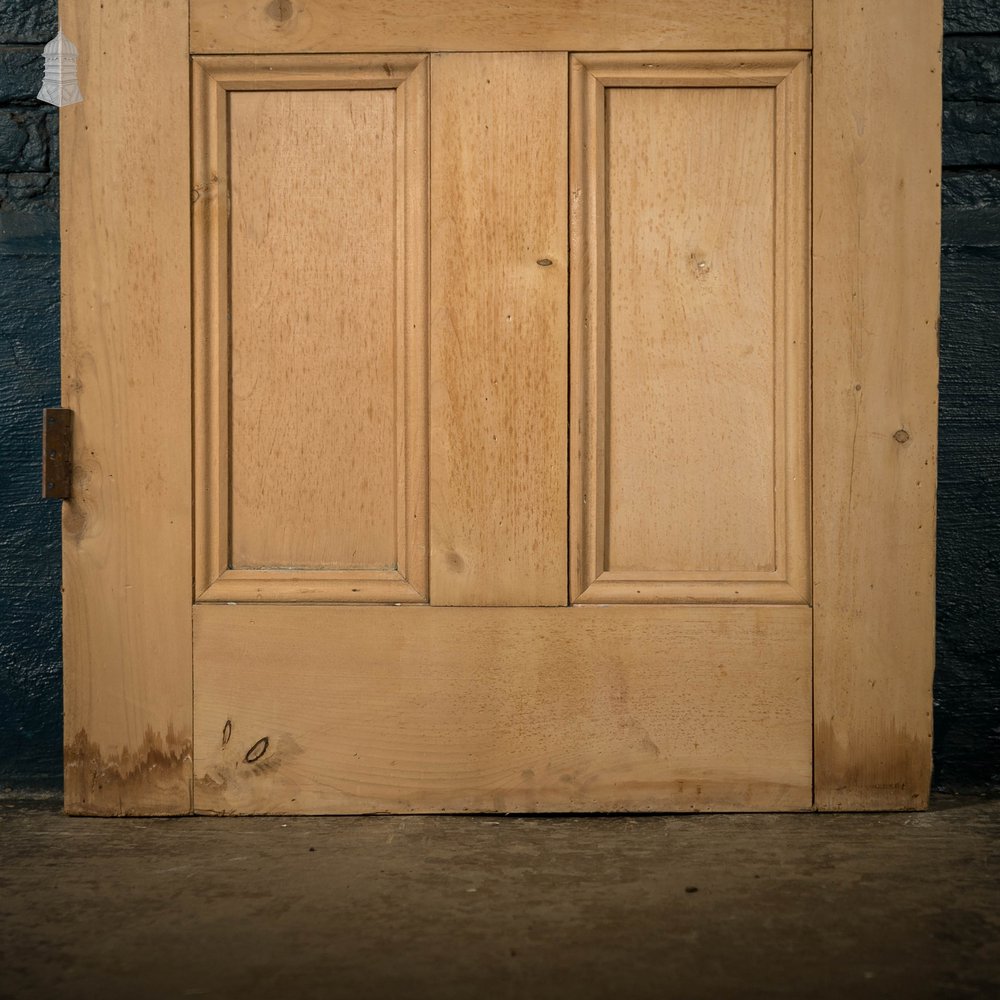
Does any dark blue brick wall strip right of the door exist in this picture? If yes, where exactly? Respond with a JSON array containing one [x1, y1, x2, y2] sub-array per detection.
[[934, 0, 1000, 790]]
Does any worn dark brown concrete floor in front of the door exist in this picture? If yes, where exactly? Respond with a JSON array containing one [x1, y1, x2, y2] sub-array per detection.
[[0, 795, 1000, 1000]]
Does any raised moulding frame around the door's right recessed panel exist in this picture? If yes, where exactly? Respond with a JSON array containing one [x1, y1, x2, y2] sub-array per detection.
[[569, 51, 811, 604]]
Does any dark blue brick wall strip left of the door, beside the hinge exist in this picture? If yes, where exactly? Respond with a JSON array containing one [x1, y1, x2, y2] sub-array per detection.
[[0, 0, 62, 788]]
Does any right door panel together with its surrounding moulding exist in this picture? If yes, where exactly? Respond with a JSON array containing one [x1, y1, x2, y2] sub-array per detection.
[[570, 52, 809, 603]]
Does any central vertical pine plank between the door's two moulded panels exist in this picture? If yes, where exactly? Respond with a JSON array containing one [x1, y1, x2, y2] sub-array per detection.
[[430, 53, 567, 605]]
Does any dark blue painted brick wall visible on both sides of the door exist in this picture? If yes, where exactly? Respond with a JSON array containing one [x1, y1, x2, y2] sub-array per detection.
[[0, 0, 1000, 792]]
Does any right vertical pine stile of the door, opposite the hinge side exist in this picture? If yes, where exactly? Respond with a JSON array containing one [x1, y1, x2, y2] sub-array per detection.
[[814, 0, 942, 809]]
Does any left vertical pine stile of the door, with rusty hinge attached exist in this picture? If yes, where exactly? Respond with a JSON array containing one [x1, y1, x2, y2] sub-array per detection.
[[60, 0, 192, 815]]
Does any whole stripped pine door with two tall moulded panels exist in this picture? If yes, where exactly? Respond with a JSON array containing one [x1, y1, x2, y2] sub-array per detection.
[[63, 0, 940, 813]]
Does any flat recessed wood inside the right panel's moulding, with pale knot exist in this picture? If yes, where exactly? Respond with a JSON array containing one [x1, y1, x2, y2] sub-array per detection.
[[605, 87, 776, 574]]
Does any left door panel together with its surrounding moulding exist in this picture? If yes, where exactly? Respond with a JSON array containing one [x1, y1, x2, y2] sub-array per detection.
[[193, 56, 427, 602]]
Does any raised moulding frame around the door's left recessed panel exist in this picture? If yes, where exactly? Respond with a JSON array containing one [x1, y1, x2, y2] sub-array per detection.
[[192, 54, 428, 604]]
